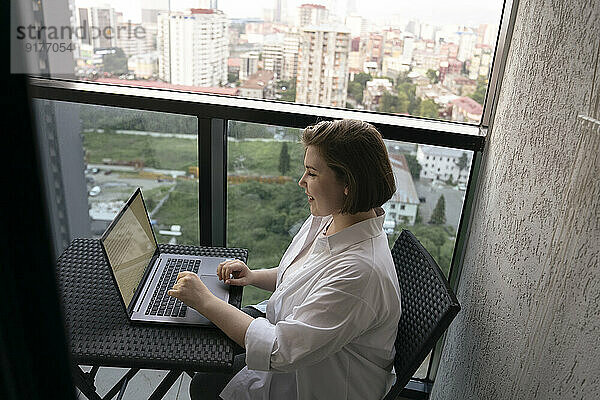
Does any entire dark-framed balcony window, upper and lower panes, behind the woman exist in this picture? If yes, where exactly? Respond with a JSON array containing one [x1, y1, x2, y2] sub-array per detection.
[[22, 0, 501, 388]]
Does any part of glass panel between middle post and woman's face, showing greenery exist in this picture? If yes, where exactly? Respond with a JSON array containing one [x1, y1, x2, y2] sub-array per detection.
[[226, 121, 310, 305]]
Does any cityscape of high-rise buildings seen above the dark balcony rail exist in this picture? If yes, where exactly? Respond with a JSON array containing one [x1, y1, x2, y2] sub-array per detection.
[[70, 0, 500, 124]]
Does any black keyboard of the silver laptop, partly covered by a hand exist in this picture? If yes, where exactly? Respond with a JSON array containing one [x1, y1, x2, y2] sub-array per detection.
[[146, 258, 200, 317]]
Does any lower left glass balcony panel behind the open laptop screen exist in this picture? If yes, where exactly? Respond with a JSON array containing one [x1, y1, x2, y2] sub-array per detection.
[[34, 99, 199, 254]]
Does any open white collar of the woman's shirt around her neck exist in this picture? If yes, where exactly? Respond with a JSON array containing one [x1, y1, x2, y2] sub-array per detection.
[[315, 207, 385, 253]]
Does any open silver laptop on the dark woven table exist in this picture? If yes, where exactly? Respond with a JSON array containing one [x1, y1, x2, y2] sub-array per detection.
[[100, 188, 230, 326]]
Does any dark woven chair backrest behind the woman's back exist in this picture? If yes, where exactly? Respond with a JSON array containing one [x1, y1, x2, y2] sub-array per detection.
[[384, 230, 460, 400]]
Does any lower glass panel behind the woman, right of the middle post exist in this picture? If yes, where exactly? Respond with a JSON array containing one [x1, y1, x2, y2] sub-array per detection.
[[226, 121, 473, 304]]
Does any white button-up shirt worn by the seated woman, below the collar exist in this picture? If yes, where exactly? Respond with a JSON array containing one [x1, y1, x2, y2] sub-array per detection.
[[221, 208, 400, 400]]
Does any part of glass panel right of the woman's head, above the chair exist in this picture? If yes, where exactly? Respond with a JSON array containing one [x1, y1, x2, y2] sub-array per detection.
[[383, 140, 473, 278]]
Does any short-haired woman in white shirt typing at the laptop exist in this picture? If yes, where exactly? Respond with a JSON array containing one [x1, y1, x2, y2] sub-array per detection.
[[169, 120, 400, 399]]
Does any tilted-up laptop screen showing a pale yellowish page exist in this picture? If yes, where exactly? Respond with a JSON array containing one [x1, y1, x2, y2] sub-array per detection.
[[101, 190, 156, 308]]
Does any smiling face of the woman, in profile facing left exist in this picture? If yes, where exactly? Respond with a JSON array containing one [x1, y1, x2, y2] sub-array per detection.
[[298, 146, 348, 216]]
